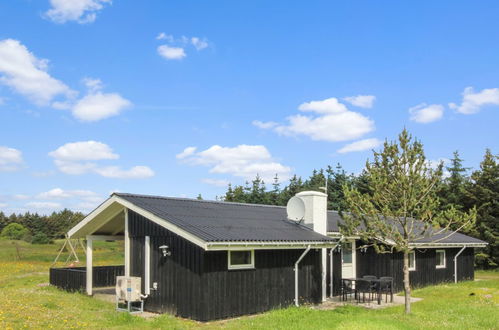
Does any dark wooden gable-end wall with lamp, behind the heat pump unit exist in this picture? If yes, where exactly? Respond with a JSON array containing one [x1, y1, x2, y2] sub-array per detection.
[[128, 211, 207, 320]]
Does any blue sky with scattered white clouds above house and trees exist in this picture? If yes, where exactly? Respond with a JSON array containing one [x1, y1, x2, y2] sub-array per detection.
[[0, 0, 499, 213]]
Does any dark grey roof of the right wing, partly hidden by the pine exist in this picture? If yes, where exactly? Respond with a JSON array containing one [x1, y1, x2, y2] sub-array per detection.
[[327, 211, 487, 244]]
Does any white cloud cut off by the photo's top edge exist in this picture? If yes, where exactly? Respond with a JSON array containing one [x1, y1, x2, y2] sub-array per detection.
[[45, 0, 111, 24]]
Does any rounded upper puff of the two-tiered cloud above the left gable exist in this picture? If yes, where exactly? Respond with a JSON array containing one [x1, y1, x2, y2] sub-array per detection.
[[49, 141, 120, 161]]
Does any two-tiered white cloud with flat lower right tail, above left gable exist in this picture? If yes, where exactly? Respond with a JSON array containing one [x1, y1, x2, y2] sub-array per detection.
[[49, 141, 154, 179]]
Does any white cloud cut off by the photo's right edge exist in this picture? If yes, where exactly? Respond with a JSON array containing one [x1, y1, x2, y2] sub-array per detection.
[[449, 87, 499, 115]]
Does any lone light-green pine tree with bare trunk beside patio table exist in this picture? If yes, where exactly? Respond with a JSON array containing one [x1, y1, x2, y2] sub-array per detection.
[[341, 129, 476, 313]]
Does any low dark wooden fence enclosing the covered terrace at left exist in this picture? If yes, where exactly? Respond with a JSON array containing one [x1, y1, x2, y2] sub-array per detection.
[[49, 266, 125, 292]]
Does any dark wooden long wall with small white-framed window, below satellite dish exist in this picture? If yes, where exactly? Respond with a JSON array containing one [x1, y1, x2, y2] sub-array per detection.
[[202, 249, 321, 320]]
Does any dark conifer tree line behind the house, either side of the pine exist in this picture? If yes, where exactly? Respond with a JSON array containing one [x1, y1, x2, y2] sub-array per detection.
[[223, 149, 499, 268]]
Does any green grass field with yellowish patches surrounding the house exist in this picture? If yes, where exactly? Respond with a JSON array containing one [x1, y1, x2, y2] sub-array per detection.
[[0, 240, 499, 329]]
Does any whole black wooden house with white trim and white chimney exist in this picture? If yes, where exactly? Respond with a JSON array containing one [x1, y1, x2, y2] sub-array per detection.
[[51, 192, 485, 321]]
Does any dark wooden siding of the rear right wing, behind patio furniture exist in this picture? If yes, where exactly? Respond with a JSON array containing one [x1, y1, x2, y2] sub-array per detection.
[[356, 248, 474, 291]]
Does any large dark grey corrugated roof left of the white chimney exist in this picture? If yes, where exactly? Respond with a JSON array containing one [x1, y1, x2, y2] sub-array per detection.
[[114, 193, 335, 243]]
